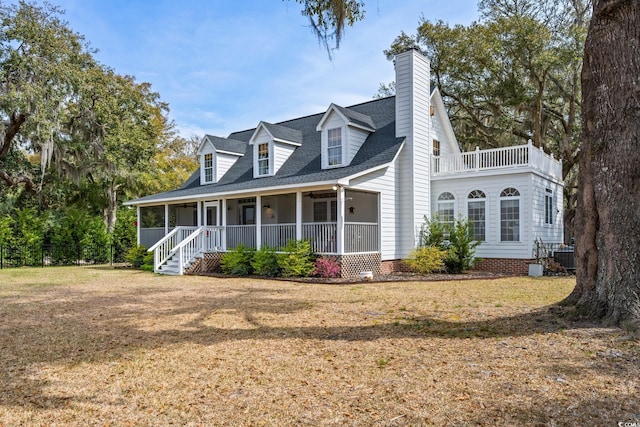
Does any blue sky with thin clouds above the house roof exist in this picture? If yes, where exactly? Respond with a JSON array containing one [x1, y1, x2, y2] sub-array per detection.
[[42, 0, 478, 138]]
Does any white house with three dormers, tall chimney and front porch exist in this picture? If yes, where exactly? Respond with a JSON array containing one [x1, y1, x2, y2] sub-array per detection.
[[126, 50, 563, 277]]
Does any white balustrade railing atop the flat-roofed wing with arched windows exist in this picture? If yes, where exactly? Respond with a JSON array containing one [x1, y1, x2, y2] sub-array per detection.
[[431, 143, 562, 180]]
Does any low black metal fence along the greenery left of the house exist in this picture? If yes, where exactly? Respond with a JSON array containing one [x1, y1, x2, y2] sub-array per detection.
[[0, 244, 126, 269]]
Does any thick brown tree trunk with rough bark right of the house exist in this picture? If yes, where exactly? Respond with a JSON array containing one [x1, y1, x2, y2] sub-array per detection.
[[567, 0, 640, 331]]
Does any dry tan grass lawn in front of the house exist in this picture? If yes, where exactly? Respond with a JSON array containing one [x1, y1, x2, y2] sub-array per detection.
[[0, 267, 640, 426]]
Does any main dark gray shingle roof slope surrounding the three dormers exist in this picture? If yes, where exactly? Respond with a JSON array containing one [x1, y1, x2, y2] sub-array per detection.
[[128, 97, 404, 204]]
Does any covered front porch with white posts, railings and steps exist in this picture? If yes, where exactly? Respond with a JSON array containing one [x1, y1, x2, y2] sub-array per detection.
[[138, 186, 380, 274]]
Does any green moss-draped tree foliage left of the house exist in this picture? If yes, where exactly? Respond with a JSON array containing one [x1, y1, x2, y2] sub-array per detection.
[[0, 1, 170, 231]]
